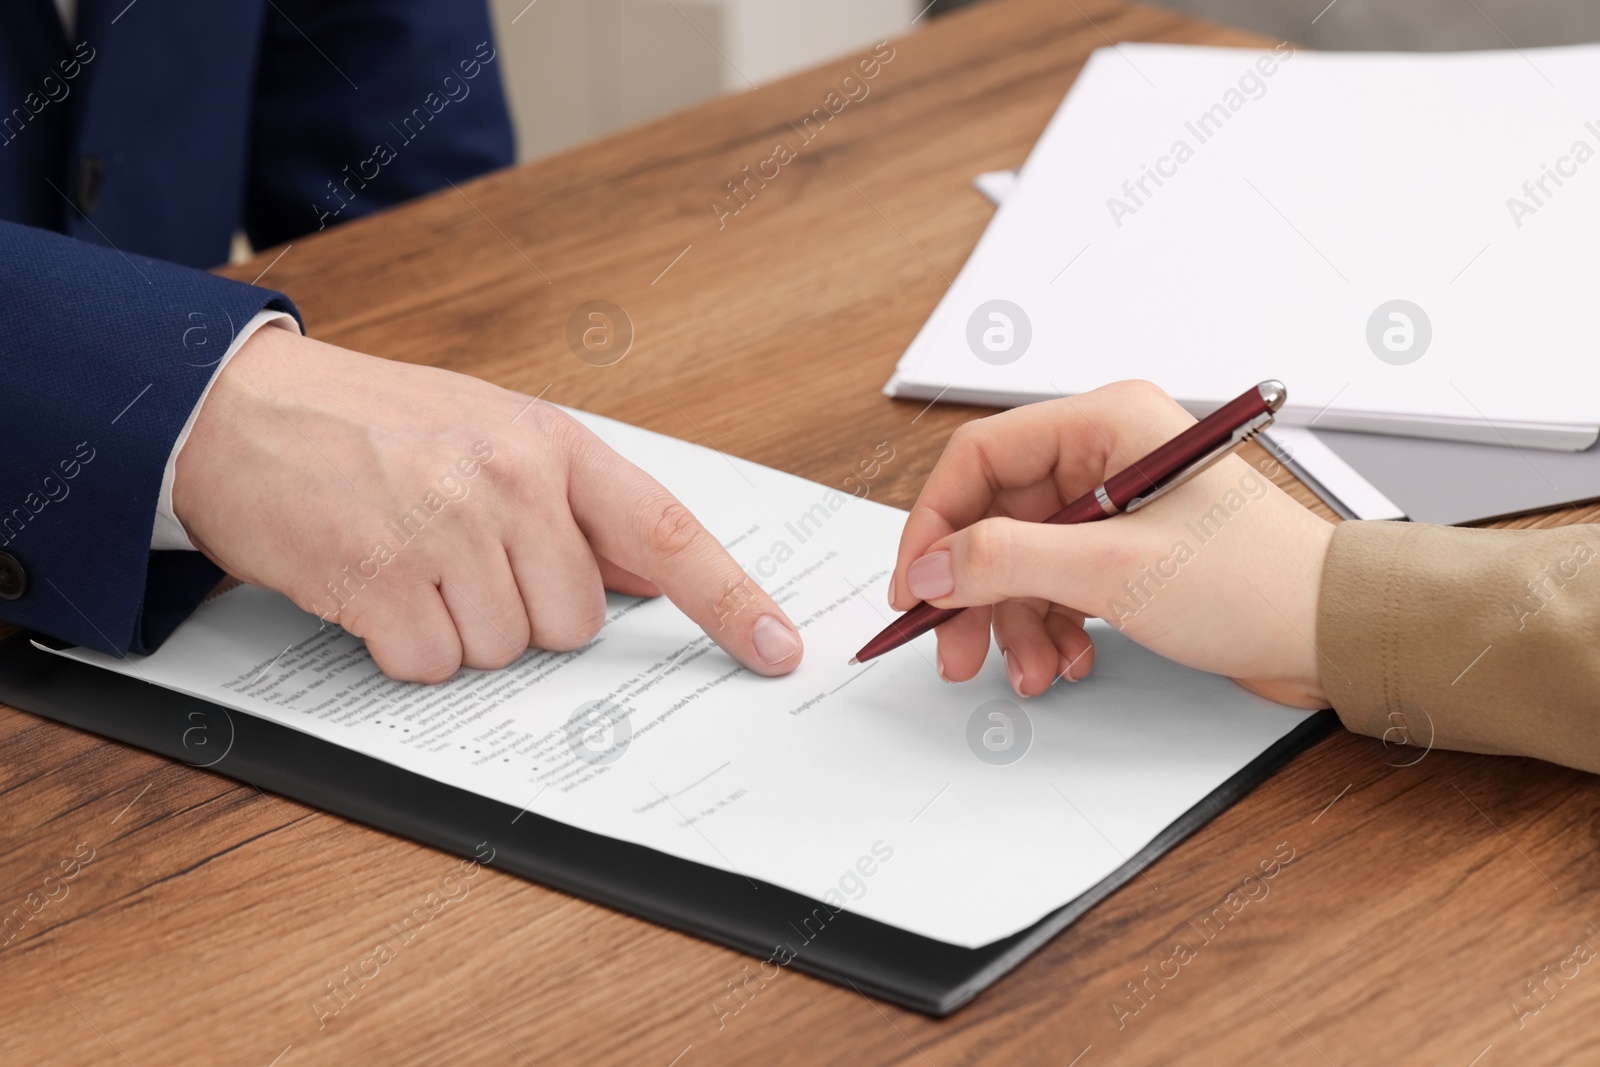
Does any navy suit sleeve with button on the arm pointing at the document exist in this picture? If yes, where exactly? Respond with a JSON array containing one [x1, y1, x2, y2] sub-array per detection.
[[0, 222, 299, 654]]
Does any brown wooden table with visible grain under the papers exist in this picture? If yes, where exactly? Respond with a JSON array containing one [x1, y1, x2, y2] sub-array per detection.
[[0, 0, 1600, 1067]]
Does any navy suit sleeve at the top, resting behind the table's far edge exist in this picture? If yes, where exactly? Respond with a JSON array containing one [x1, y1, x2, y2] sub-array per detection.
[[245, 0, 514, 248]]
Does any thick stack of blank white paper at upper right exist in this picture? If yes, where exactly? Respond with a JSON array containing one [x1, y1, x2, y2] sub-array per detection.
[[886, 45, 1600, 451]]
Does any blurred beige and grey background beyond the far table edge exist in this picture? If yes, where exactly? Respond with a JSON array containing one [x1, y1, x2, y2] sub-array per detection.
[[491, 0, 1600, 160]]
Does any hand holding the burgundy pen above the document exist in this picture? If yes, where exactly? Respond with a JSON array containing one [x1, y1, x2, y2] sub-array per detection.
[[890, 382, 1333, 707]]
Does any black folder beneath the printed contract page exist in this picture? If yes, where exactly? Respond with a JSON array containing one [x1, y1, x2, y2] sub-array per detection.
[[0, 635, 1338, 1016]]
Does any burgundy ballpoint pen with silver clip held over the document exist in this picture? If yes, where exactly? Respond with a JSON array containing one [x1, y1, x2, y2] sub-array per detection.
[[850, 381, 1288, 664]]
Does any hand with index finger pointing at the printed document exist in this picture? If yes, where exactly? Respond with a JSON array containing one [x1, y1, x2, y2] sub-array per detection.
[[173, 328, 802, 683]]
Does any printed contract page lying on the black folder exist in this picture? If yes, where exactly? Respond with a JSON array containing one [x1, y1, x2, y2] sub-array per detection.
[[43, 413, 1306, 947]]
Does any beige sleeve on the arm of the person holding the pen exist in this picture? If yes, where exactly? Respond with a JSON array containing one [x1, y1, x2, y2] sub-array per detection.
[[1317, 522, 1600, 771]]
